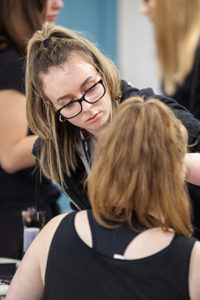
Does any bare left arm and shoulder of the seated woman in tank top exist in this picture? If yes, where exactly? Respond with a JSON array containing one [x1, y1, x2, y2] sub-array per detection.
[[6, 213, 67, 300]]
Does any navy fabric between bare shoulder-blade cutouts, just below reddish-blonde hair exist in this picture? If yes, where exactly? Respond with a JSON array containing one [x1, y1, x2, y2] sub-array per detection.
[[87, 210, 144, 257]]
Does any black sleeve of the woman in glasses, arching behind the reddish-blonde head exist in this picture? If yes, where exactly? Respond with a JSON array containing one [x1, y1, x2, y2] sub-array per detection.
[[121, 80, 200, 152]]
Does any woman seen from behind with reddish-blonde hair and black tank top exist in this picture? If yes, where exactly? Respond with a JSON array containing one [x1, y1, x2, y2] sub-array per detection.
[[6, 97, 200, 300]]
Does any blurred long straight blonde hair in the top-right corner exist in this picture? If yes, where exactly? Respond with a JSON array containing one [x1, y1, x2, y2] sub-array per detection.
[[154, 0, 200, 95]]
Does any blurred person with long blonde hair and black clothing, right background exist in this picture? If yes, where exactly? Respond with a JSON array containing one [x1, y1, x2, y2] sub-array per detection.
[[141, 0, 200, 238]]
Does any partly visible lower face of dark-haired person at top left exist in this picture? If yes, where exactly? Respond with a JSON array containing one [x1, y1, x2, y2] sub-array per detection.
[[46, 0, 64, 23]]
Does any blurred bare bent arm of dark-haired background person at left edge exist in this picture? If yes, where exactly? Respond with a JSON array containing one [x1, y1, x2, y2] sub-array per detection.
[[0, 90, 37, 173]]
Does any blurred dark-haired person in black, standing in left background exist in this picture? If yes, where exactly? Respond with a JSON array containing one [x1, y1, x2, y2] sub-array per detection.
[[0, 0, 62, 259]]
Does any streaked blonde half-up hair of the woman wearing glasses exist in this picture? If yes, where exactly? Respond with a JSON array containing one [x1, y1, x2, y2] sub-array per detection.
[[26, 24, 121, 188]]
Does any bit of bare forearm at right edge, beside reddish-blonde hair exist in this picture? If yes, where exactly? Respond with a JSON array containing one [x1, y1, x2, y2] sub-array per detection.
[[184, 153, 200, 185]]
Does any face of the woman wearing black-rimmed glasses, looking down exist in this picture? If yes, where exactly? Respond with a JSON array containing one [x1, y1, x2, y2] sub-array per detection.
[[40, 54, 112, 139]]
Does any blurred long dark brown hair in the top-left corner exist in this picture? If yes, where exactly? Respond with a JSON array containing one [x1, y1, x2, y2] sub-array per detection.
[[0, 0, 47, 53]]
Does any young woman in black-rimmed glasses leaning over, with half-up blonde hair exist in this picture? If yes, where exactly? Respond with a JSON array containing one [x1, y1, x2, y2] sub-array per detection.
[[26, 25, 200, 234]]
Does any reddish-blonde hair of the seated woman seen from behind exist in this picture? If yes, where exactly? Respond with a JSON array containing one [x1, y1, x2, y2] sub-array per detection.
[[87, 97, 192, 236]]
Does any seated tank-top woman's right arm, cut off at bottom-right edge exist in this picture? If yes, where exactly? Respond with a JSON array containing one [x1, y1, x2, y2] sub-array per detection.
[[189, 242, 200, 300]]
